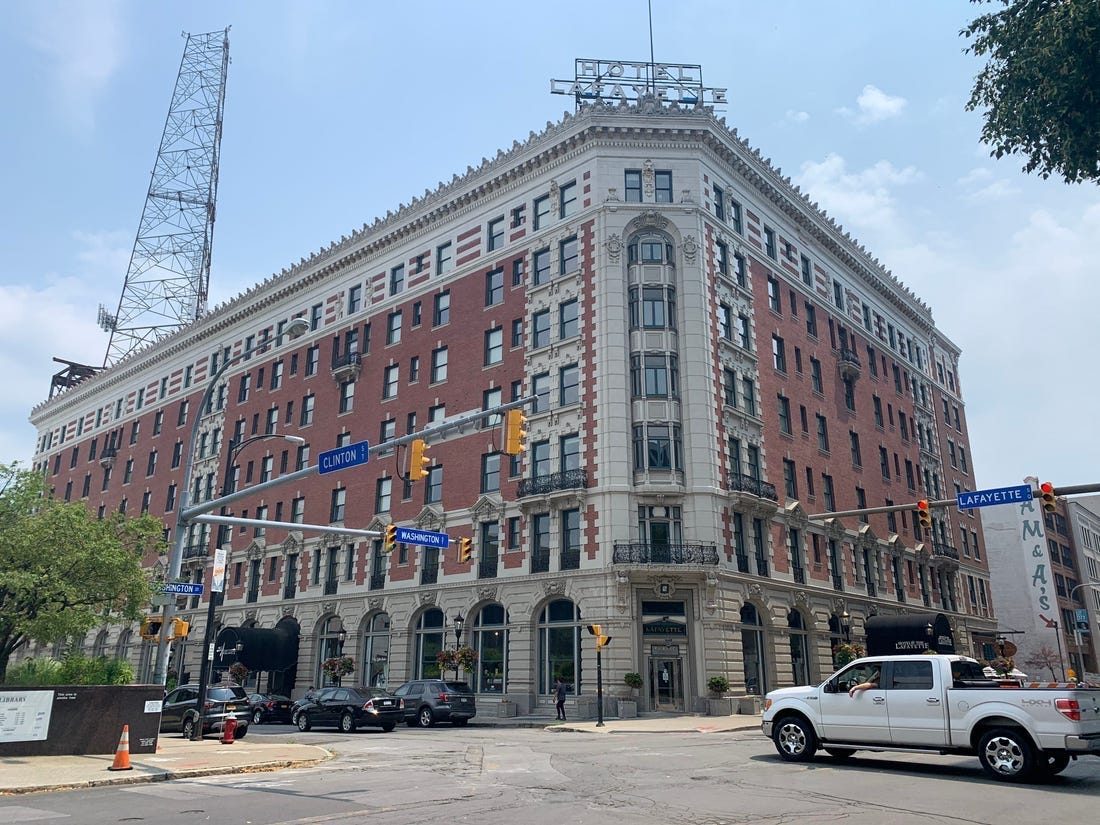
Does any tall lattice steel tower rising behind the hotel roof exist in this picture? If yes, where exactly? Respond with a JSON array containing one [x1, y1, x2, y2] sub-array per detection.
[[99, 29, 229, 366]]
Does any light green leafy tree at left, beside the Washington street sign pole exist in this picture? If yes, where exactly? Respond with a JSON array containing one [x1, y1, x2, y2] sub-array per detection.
[[0, 463, 164, 683]]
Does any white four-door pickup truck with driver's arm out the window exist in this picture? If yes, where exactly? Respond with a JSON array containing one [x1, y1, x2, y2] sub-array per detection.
[[762, 655, 1100, 781]]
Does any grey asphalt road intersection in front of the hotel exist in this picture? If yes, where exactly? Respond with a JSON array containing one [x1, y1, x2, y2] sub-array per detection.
[[0, 725, 1100, 825]]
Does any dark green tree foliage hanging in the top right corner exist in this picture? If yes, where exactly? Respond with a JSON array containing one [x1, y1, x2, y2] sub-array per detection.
[[960, 0, 1100, 184]]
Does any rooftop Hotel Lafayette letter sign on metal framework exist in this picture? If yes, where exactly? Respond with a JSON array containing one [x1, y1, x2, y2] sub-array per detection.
[[550, 59, 726, 107]]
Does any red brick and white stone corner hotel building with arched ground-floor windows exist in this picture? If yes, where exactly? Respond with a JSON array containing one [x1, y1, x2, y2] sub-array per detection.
[[31, 95, 996, 711]]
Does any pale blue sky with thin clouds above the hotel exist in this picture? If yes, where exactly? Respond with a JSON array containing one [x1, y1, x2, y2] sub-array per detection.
[[0, 0, 1100, 495]]
